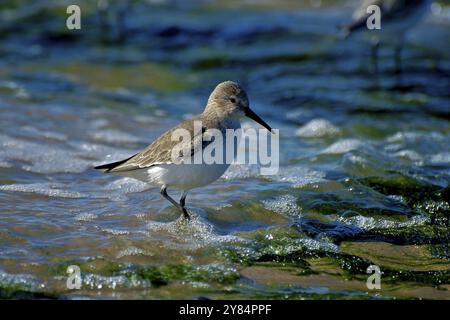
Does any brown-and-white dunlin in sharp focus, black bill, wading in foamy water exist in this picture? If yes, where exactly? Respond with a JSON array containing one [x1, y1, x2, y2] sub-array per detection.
[[95, 81, 272, 219]]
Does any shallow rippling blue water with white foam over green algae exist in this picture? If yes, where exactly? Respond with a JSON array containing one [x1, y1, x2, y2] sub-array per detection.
[[0, 1, 450, 299]]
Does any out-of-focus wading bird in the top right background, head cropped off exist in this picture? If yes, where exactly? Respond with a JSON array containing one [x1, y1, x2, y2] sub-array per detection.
[[344, 0, 432, 71]]
